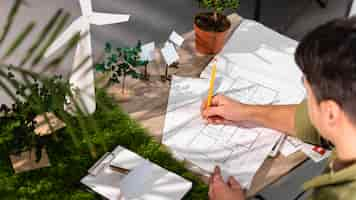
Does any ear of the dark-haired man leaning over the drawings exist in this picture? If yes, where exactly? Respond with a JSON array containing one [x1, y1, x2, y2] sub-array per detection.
[[320, 100, 342, 127]]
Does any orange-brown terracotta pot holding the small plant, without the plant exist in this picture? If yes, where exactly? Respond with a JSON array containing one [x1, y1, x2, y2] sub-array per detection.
[[194, 13, 231, 54]]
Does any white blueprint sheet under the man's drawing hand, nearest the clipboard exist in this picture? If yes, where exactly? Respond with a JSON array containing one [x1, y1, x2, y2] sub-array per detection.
[[163, 76, 288, 188]]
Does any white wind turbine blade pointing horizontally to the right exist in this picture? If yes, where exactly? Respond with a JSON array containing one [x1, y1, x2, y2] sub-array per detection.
[[89, 12, 130, 25]]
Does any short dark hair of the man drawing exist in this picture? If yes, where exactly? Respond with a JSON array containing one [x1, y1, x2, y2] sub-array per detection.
[[295, 17, 356, 121]]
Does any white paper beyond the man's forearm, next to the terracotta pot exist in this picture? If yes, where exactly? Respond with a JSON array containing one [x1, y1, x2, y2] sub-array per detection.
[[201, 20, 306, 104]]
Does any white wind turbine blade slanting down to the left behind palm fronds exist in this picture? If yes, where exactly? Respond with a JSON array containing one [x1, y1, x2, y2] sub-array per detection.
[[44, 17, 87, 58]]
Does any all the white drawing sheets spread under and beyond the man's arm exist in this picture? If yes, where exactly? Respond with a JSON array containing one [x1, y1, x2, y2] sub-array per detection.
[[163, 20, 305, 188]]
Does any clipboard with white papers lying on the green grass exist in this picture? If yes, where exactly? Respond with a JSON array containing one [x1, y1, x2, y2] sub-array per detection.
[[80, 146, 192, 200]]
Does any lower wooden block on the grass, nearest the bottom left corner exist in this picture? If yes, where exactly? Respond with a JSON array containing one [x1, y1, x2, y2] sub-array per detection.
[[10, 148, 51, 174]]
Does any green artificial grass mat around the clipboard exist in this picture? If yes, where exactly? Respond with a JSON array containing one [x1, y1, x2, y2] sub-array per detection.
[[0, 90, 208, 200]]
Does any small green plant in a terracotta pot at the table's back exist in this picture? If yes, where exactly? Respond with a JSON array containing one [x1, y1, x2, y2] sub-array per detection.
[[194, 0, 240, 54]]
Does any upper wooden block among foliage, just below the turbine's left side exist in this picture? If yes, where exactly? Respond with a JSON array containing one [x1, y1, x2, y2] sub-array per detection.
[[35, 112, 65, 136]]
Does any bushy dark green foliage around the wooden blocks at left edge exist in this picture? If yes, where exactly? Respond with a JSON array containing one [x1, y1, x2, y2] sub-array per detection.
[[0, 71, 69, 161]]
